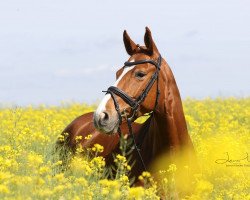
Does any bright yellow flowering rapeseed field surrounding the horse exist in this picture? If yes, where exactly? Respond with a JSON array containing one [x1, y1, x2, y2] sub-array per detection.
[[0, 98, 250, 200]]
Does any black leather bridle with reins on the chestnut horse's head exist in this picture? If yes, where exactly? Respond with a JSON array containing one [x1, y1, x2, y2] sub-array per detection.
[[103, 55, 162, 171]]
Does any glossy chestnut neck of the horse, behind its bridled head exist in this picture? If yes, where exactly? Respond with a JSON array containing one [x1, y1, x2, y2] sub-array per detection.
[[145, 61, 193, 156]]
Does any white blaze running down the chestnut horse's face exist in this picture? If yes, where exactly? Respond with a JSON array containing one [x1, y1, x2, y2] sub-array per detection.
[[95, 60, 135, 115]]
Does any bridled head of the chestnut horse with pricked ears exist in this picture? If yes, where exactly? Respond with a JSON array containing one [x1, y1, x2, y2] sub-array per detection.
[[94, 27, 162, 134]]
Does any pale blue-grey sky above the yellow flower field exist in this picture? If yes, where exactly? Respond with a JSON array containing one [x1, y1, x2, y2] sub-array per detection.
[[0, 0, 250, 105]]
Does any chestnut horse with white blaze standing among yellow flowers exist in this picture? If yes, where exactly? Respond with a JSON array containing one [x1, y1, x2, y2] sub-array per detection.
[[57, 27, 196, 184]]
